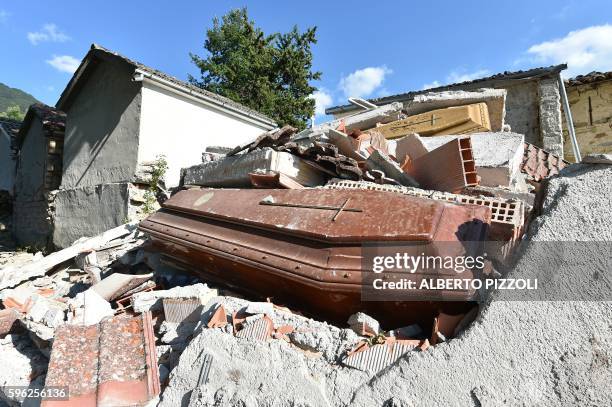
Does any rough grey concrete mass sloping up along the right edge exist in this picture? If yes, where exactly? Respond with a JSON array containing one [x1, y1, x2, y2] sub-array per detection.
[[351, 165, 612, 406]]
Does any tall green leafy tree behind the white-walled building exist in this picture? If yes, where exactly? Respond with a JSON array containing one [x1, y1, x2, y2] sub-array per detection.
[[189, 8, 321, 128]]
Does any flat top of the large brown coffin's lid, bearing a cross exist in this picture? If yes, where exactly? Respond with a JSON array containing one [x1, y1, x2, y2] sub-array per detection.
[[158, 189, 481, 243]]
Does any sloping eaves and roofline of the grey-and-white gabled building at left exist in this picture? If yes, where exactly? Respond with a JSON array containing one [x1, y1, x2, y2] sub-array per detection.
[[56, 44, 276, 128]]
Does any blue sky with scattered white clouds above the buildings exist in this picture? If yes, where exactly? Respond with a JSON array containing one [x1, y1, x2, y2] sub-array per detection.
[[0, 0, 612, 119]]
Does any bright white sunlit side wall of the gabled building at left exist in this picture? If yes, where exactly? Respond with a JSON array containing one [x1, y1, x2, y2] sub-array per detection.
[[138, 81, 274, 187]]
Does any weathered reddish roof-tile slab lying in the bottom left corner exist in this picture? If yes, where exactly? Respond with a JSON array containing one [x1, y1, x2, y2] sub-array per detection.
[[42, 312, 160, 406]]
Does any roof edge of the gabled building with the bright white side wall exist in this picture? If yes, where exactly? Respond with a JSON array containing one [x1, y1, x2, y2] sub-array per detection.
[[56, 44, 276, 126]]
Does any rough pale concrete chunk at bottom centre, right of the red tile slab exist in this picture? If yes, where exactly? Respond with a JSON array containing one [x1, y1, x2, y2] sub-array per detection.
[[159, 329, 330, 407]]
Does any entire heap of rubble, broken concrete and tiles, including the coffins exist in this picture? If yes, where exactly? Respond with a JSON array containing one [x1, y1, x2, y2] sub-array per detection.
[[0, 89, 612, 406]]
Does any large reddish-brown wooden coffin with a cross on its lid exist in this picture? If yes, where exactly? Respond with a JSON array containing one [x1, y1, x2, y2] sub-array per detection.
[[140, 189, 491, 330]]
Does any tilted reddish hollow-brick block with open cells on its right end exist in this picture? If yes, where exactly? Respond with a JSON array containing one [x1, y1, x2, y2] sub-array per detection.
[[406, 137, 478, 192]]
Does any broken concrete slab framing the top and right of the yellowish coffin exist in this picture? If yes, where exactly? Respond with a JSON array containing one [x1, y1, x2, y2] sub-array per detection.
[[404, 89, 507, 131]]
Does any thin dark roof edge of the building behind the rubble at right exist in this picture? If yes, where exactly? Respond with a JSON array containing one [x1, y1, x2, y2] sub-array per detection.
[[325, 64, 567, 114]]
